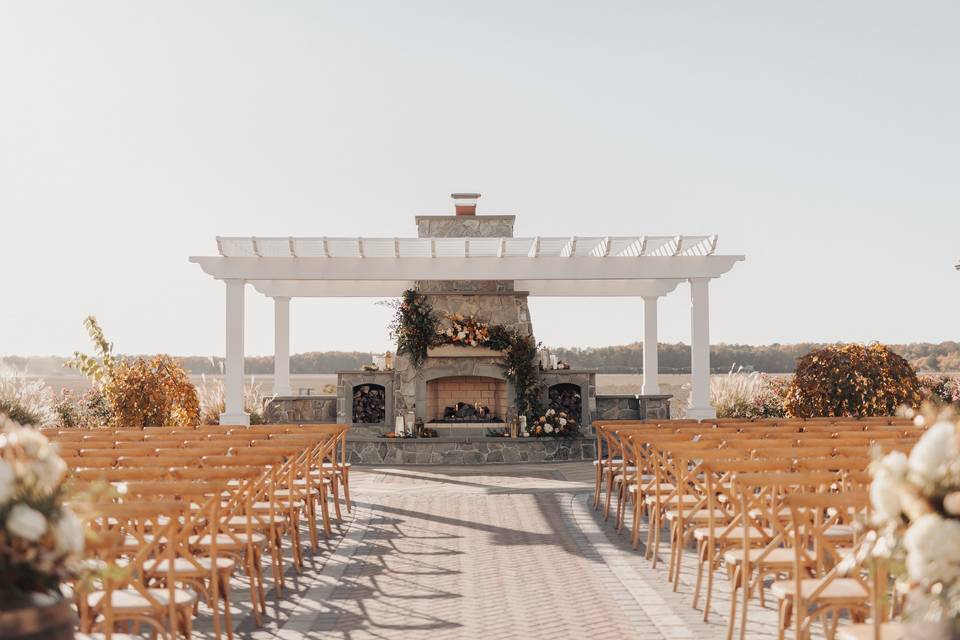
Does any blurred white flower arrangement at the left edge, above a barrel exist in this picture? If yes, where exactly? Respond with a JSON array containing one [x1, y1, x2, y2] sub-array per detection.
[[0, 418, 84, 609]]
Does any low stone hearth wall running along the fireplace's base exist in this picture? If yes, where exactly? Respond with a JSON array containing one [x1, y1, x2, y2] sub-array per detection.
[[347, 432, 596, 464]]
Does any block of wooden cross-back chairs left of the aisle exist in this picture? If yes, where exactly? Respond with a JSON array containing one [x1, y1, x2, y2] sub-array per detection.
[[46, 425, 352, 640]]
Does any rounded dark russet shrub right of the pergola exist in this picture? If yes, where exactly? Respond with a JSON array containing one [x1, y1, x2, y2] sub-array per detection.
[[784, 344, 920, 418]]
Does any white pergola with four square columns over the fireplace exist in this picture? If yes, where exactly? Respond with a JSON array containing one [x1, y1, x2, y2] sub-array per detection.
[[190, 235, 744, 424]]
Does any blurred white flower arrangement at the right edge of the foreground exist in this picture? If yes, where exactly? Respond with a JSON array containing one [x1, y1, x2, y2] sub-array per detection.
[[870, 409, 960, 637]]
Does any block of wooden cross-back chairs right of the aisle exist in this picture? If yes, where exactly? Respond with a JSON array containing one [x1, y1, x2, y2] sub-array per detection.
[[594, 419, 922, 640]]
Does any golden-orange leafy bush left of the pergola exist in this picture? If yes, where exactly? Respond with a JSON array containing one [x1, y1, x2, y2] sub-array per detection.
[[103, 355, 200, 427]]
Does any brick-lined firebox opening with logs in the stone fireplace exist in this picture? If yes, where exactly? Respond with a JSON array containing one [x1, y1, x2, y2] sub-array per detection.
[[426, 376, 507, 423]]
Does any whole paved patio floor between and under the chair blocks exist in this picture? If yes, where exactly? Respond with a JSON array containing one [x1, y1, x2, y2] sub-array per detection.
[[195, 462, 832, 640]]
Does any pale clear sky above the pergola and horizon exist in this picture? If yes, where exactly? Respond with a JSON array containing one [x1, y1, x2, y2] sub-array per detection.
[[0, 0, 960, 355]]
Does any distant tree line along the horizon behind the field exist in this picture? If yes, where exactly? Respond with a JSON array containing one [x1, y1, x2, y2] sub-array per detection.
[[7, 342, 960, 375]]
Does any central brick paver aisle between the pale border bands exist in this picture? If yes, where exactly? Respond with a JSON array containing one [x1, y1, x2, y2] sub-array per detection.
[[310, 468, 642, 639]]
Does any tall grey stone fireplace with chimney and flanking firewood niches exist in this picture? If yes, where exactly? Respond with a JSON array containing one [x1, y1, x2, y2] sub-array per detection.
[[338, 194, 596, 438]]
